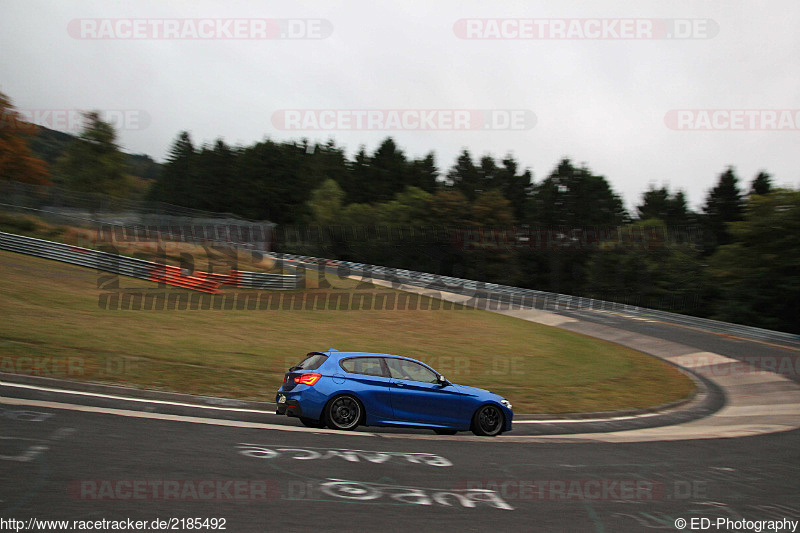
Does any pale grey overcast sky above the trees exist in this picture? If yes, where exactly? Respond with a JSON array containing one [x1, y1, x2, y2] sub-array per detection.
[[0, 0, 800, 212]]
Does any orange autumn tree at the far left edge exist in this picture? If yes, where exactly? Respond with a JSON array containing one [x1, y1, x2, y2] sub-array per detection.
[[0, 93, 50, 185]]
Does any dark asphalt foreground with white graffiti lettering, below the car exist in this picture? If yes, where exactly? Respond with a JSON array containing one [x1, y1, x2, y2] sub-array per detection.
[[0, 406, 800, 532]]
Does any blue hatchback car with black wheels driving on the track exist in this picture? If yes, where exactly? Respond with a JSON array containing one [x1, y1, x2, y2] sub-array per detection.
[[275, 349, 514, 436]]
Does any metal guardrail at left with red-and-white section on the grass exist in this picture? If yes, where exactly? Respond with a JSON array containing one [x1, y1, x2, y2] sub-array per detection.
[[0, 232, 304, 294]]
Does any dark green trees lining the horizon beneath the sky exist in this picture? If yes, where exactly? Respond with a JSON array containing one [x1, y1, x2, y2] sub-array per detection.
[[0, 92, 800, 332]]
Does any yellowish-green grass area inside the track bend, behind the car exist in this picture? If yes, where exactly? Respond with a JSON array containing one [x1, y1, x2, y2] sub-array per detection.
[[0, 247, 694, 413]]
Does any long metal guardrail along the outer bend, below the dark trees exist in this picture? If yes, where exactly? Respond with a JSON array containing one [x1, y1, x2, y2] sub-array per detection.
[[267, 253, 800, 347]]
